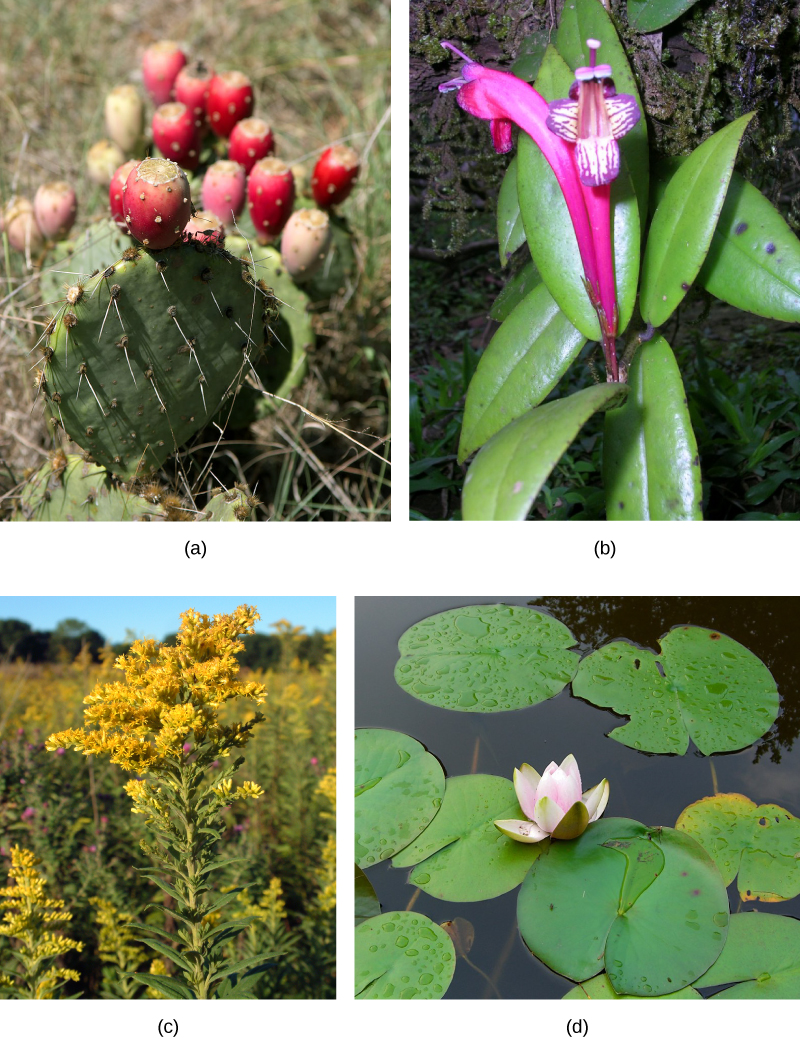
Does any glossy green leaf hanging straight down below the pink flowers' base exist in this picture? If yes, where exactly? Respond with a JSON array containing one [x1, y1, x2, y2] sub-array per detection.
[[604, 336, 702, 520]]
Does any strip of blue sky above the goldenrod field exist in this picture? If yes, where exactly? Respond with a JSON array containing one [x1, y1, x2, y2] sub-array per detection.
[[0, 595, 336, 642]]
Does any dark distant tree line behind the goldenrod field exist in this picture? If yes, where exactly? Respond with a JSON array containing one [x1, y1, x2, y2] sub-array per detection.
[[0, 617, 325, 669]]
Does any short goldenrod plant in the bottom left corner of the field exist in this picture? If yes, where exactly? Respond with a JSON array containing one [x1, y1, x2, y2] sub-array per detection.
[[0, 845, 83, 1000]]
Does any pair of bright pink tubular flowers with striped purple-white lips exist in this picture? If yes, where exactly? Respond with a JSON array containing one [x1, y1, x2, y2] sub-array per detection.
[[439, 39, 641, 382]]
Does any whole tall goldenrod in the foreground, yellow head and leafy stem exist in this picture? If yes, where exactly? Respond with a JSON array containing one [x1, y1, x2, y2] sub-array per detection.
[[47, 606, 278, 1000]]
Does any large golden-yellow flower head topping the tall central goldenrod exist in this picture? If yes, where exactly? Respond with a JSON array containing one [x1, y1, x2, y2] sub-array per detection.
[[47, 606, 264, 773]]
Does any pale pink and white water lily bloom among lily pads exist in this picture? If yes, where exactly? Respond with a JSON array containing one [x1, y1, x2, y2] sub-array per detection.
[[495, 754, 609, 844]]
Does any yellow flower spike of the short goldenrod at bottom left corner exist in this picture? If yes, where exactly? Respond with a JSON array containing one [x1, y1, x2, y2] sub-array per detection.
[[0, 845, 83, 1000]]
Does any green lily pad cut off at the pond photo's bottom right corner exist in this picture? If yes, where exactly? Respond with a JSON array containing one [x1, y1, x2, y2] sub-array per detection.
[[696, 912, 800, 1000]]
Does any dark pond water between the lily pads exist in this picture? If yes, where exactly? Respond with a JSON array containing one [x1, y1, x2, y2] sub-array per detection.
[[355, 595, 800, 1000]]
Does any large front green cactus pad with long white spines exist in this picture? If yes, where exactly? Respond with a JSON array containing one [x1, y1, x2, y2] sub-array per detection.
[[41, 239, 274, 480]]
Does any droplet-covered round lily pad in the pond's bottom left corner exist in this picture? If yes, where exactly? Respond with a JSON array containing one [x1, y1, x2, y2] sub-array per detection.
[[355, 912, 456, 1000]]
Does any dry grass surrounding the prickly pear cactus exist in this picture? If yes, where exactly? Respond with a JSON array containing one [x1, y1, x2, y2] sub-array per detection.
[[0, 0, 390, 521]]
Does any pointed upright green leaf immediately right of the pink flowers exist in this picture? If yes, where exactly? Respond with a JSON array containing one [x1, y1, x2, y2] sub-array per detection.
[[639, 112, 753, 327]]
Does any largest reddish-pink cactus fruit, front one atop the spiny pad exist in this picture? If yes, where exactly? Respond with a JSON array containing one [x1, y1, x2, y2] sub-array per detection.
[[123, 159, 191, 249]]
